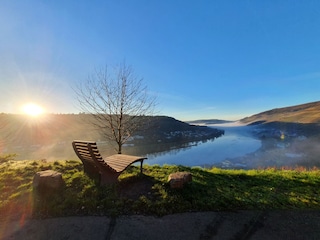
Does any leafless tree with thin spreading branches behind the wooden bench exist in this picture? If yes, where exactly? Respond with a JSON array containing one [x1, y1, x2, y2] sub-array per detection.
[[75, 63, 156, 154]]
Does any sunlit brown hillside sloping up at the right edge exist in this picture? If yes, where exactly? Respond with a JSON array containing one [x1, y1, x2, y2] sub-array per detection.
[[240, 101, 320, 124]]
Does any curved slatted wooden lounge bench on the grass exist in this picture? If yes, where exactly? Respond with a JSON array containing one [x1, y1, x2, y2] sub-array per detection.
[[72, 141, 147, 185]]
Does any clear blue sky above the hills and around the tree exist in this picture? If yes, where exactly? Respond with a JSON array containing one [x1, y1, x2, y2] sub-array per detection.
[[0, 0, 320, 120]]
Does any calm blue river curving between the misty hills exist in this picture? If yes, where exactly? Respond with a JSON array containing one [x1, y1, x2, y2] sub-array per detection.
[[146, 124, 261, 167]]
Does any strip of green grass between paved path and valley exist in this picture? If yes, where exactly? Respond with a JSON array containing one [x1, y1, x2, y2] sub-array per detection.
[[0, 161, 320, 217]]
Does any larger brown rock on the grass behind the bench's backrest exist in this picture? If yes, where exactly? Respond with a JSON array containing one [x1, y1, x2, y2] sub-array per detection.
[[32, 170, 64, 190]]
